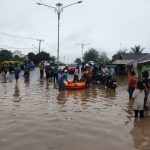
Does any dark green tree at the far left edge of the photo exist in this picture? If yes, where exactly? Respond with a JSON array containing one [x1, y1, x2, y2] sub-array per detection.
[[0, 49, 13, 61]]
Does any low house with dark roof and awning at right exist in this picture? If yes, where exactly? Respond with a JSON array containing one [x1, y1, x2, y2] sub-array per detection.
[[112, 53, 150, 76]]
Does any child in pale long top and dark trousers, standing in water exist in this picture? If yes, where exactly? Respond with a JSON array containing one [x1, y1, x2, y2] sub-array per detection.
[[134, 81, 144, 118]]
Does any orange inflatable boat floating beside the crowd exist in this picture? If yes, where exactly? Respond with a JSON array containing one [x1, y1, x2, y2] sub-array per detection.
[[65, 80, 88, 90]]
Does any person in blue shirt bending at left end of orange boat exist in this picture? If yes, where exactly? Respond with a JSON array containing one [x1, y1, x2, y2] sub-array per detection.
[[58, 70, 69, 91]]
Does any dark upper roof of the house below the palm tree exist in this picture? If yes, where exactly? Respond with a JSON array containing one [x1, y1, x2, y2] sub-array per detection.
[[121, 53, 148, 60]]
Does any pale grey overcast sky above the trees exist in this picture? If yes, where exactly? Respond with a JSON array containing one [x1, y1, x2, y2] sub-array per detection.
[[0, 0, 150, 62]]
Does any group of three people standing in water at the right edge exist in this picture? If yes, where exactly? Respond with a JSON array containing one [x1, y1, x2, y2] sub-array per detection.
[[128, 71, 150, 118]]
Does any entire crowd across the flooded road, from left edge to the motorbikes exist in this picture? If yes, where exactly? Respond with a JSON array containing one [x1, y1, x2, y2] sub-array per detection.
[[0, 61, 115, 90]]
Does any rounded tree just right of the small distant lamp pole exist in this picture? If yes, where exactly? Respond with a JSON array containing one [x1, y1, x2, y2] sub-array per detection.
[[83, 48, 99, 63]]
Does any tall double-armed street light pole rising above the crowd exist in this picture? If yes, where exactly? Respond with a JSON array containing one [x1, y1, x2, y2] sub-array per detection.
[[37, 1, 82, 62]]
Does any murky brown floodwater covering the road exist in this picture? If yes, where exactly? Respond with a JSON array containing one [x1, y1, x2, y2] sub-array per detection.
[[0, 70, 150, 150]]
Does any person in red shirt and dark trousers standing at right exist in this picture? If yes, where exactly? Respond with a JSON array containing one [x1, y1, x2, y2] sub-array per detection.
[[128, 71, 137, 100]]
